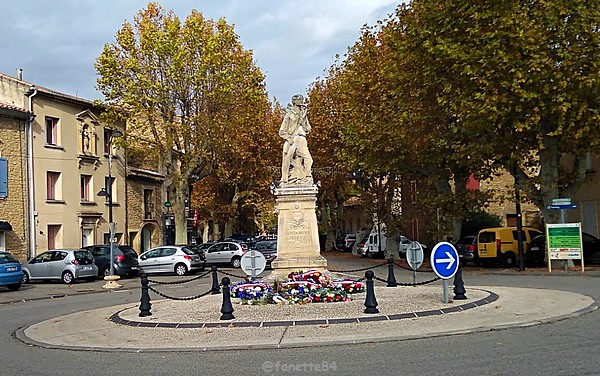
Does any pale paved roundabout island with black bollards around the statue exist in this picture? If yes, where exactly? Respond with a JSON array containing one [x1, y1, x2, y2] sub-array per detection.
[[16, 285, 598, 352]]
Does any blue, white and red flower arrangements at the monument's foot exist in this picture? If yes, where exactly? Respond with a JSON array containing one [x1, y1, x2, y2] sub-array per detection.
[[230, 270, 365, 304]]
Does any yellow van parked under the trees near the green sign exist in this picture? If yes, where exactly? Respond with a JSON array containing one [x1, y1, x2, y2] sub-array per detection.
[[477, 227, 542, 267]]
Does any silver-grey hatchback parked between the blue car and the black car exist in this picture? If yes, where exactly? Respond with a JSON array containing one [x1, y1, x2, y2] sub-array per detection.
[[21, 249, 98, 284]]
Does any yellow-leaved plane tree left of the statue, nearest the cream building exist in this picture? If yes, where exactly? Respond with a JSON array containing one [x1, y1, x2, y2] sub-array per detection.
[[96, 3, 268, 243]]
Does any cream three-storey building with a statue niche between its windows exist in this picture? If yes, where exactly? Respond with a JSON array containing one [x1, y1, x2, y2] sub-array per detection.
[[0, 74, 164, 260]]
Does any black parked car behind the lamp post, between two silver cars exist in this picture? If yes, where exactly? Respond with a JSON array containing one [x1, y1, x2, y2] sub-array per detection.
[[83, 244, 139, 277]]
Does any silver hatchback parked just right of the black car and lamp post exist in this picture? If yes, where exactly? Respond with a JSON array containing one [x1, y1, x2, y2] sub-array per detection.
[[138, 245, 204, 276]]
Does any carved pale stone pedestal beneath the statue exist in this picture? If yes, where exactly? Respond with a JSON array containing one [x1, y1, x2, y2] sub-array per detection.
[[270, 186, 327, 280]]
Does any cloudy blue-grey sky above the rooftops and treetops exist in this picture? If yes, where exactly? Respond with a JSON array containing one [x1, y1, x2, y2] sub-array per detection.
[[0, 0, 400, 104]]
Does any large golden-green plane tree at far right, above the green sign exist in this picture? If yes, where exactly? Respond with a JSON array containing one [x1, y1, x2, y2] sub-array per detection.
[[391, 0, 600, 222]]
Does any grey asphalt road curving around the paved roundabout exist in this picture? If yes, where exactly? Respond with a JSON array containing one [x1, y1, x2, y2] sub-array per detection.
[[0, 255, 600, 376]]
